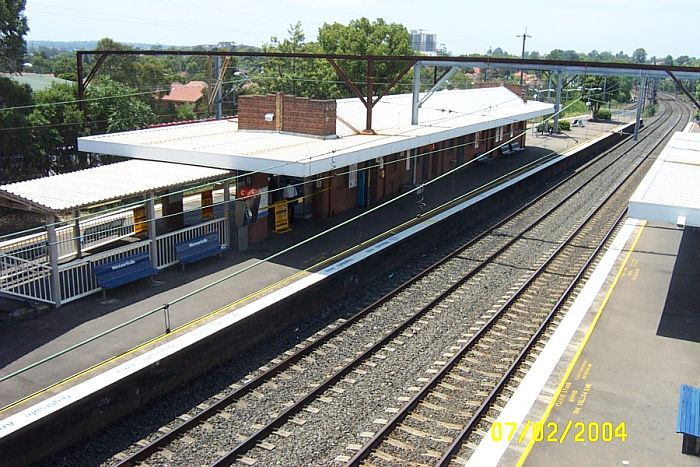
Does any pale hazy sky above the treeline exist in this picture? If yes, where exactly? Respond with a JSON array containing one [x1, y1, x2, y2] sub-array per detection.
[[25, 0, 700, 57]]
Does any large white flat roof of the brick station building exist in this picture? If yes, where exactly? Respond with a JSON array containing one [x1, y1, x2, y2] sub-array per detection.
[[78, 87, 554, 177]]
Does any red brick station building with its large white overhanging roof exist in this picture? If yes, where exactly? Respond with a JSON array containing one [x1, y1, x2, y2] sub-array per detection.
[[78, 86, 553, 249]]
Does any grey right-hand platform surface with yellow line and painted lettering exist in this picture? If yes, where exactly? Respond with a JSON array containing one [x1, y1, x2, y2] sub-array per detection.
[[512, 224, 700, 466]]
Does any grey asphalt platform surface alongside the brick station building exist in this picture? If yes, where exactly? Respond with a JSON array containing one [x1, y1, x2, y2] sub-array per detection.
[[0, 116, 620, 421]]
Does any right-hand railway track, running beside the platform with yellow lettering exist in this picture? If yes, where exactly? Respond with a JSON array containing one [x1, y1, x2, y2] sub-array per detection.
[[348, 98, 682, 466]]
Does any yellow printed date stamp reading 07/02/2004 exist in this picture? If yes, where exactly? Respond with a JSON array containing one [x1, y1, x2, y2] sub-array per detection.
[[490, 420, 627, 444]]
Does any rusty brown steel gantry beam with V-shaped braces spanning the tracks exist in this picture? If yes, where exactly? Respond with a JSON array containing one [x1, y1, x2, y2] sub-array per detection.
[[76, 50, 700, 128]]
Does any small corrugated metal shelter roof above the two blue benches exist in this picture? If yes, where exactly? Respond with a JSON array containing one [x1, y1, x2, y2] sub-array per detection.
[[0, 160, 230, 213]]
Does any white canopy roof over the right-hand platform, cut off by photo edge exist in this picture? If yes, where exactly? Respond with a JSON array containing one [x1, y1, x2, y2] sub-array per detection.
[[629, 132, 700, 227]]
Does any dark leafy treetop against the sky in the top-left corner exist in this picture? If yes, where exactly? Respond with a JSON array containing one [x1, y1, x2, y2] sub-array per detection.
[[0, 0, 29, 73]]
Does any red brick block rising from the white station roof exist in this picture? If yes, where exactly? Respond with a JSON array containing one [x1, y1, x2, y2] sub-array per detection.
[[238, 94, 336, 136]]
